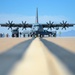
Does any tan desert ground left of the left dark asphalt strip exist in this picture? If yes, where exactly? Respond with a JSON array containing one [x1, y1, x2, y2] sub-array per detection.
[[0, 38, 30, 53]]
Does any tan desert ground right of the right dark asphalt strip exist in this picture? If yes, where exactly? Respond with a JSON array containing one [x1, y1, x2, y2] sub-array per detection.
[[45, 37, 75, 53]]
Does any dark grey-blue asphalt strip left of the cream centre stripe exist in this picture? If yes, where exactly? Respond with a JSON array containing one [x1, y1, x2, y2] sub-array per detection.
[[0, 38, 33, 75]]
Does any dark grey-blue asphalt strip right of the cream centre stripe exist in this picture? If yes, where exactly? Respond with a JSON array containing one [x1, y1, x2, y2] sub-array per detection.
[[40, 39, 75, 75]]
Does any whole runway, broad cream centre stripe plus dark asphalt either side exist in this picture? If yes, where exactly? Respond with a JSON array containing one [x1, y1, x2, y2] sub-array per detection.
[[0, 38, 75, 75]]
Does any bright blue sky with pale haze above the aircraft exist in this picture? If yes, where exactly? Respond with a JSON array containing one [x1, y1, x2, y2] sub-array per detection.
[[0, 0, 75, 33]]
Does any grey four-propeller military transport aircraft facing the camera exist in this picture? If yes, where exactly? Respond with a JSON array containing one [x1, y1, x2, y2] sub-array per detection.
[[0, 8, 75, 37]]
